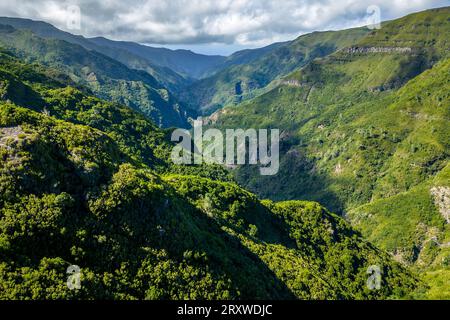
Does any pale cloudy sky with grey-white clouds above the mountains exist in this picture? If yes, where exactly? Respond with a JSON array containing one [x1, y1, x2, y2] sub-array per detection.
[[0, 0, 450, 54]]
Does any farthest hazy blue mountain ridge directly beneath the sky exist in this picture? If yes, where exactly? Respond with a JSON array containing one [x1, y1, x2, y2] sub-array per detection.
[[0, 17, 288, 83]]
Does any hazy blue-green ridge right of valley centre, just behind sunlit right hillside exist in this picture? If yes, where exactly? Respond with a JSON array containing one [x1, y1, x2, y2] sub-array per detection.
[[181, 28, 368, 114]]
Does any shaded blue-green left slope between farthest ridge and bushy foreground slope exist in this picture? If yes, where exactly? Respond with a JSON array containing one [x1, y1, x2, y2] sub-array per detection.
[[0, 25, 190, 127]]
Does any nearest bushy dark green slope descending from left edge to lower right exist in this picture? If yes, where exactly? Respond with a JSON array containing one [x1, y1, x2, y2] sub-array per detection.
[[0, 52, 420, 299]]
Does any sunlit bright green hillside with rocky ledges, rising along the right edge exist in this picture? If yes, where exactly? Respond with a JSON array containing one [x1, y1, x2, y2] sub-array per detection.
[[210, 7, 450, 298]]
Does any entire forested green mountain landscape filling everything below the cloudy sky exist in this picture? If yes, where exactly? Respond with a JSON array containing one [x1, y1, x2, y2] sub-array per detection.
[[0, 7, 450, 299]]
